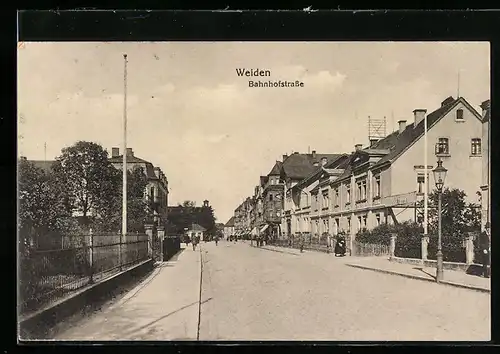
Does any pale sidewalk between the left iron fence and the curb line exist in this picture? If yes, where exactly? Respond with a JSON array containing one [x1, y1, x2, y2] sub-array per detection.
[[55, 245, 201, 340]]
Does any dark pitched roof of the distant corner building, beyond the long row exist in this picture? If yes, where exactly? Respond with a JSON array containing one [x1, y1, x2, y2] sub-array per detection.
[[282, 153, 343, 179]]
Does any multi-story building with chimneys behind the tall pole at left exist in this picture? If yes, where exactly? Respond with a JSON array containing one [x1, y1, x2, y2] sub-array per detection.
[[109, 148, 168, 224]]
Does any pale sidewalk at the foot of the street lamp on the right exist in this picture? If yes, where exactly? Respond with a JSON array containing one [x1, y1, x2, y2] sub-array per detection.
[[346, 257, 491, 293]]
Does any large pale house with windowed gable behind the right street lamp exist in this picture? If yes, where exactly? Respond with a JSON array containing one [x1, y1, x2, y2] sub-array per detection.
[[330, 97, 482, 253]]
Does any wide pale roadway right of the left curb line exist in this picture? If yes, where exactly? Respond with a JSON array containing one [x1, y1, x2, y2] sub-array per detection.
[[200, 242, 490, 341]]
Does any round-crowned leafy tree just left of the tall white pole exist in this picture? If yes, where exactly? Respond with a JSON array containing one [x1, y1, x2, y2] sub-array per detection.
[[54, 141, 120, 221]]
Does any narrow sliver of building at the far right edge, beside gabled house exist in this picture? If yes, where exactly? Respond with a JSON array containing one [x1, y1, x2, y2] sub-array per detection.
[[478, 100, 491, 231]]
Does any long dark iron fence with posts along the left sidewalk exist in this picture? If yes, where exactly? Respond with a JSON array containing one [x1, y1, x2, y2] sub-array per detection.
[[19, 234, 149, 312]]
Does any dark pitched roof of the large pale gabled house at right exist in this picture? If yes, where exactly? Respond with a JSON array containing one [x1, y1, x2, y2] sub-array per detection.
[[370, 97, 479, 166]]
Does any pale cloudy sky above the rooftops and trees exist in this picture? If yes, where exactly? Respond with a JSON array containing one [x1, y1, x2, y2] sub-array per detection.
[[18, 42, 490, 223]]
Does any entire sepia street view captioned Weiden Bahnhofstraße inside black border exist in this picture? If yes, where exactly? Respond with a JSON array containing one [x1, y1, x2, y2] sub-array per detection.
[[17, 41, 491, 342]]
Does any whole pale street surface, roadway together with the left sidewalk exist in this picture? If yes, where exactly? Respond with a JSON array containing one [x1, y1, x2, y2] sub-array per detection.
[[53, 241, 490, 341]]
